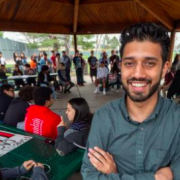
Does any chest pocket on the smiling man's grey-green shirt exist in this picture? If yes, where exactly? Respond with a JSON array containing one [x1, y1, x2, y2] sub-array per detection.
[[145, 149, 168, 172]]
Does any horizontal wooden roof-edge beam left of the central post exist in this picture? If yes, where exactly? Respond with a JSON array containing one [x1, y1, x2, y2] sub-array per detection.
[[0, 20, 72, 34]]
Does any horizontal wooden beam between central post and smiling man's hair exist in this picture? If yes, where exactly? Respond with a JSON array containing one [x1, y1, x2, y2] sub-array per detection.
[[77, 23, 132, 34]]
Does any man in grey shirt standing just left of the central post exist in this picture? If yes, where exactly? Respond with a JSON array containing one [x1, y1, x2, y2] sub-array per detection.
[[61, 51, 71, 81]]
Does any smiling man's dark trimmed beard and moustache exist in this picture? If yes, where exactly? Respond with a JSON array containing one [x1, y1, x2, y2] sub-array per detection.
[[122, 76, 162, 102]]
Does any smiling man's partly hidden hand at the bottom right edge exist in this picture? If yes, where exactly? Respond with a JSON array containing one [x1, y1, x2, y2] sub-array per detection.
[[155, 167, 173, 180]]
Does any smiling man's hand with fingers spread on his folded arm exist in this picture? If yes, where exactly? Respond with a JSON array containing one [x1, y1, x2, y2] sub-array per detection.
[[88, 147, 117, 174]]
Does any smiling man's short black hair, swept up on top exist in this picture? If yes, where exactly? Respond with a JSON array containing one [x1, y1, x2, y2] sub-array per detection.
[[120, 23, 170, 63]]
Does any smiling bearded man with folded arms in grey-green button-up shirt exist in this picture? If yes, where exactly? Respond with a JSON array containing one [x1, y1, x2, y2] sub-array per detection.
[[81, 23, 180, 180]]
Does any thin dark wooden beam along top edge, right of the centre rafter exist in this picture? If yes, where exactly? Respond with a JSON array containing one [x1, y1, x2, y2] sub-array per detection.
[[80, 0, 133, 6]]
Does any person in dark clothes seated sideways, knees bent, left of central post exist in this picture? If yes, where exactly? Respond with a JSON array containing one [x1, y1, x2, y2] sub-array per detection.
[[58, 63, 74, 93]]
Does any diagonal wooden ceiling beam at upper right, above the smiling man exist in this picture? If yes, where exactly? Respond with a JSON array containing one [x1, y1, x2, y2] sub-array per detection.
[[134, 0, 174, 30]]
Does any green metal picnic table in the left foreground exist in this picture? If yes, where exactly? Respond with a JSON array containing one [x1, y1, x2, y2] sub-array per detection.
[[0, 124, 84, 180]]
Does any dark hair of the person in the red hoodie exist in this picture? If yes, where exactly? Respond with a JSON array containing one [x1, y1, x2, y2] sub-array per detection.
[[33, 87, 53, 106]]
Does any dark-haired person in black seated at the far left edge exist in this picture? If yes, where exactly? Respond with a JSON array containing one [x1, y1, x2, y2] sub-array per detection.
[[0, 84, 14, 121]]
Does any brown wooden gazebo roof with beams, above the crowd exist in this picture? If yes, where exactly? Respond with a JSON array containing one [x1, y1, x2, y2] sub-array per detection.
[[0, 0, 180, 34]]
